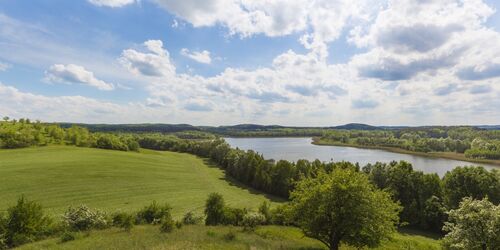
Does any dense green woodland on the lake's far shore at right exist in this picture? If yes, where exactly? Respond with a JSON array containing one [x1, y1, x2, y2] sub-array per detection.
[[319, 127, 500, 159]]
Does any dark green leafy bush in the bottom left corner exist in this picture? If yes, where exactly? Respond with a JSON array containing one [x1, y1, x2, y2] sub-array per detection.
[[0, 197, 51, 247]]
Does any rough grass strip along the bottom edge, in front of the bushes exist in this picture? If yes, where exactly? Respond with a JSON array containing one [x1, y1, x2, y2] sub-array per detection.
[[19, 226, 440, 250]]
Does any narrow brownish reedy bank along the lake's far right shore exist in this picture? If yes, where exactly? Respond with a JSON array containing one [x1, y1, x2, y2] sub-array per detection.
[[312, 137, 500, 167]]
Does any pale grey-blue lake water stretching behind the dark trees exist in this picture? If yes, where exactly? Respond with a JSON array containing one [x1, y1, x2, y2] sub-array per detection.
[[225, 138, 500, 176]]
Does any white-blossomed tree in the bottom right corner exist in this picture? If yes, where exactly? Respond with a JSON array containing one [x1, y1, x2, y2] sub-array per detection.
[[443, 198, 500, 250]]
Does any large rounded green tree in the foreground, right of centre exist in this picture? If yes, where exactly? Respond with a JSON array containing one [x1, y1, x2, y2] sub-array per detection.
[[290, 169, 400, 250]]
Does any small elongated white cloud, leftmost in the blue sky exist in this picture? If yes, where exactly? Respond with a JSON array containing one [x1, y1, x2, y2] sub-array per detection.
[[44, 64, 114, 90]]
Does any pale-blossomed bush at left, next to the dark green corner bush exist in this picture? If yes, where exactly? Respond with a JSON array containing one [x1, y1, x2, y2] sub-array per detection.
[[63, 205, 108, 231]]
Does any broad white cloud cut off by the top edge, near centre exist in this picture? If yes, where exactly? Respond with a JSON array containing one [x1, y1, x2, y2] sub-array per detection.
[[150, 0, 373, 56]]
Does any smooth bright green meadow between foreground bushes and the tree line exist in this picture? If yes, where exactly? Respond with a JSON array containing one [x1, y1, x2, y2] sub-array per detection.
[[0, 146, 282, 217]]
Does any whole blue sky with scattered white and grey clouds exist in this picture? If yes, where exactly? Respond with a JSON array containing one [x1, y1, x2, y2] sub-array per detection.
[[0, 0, 500, 126]]
